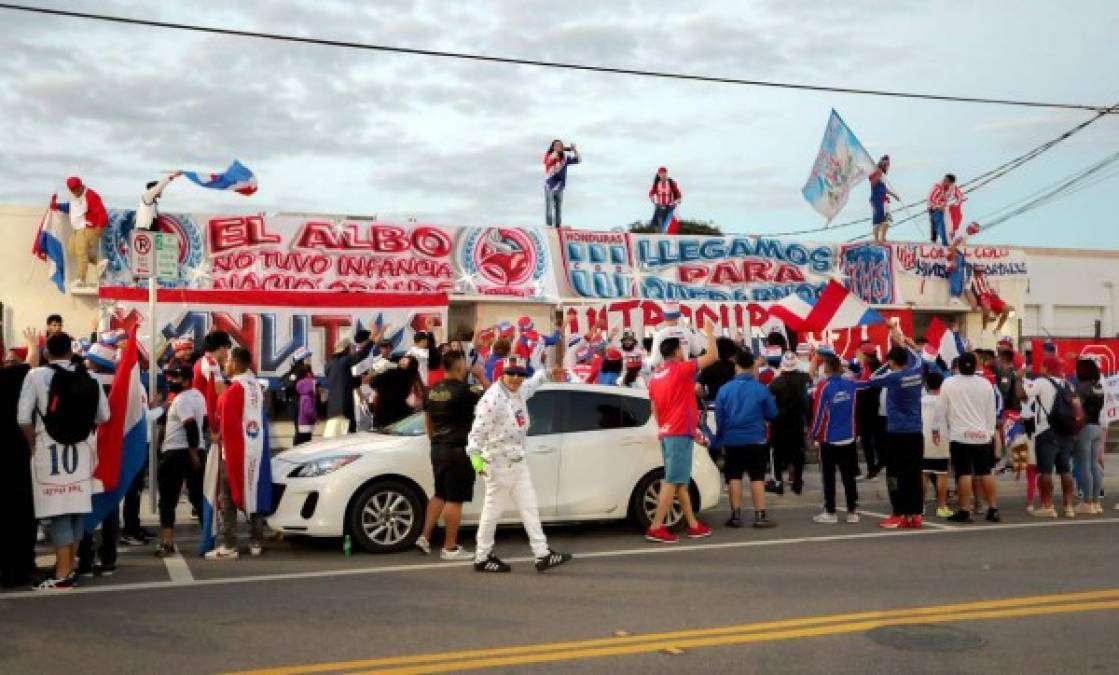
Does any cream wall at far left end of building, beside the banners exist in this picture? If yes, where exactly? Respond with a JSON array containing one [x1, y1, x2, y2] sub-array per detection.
[[0, 206, 97, 346]]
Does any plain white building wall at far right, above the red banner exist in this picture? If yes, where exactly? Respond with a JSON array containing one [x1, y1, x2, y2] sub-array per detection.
[[1022, 249, 1119, 337]]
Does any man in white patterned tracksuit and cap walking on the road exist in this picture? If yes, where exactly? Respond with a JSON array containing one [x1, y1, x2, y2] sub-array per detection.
[[467, 356, 572, 572]]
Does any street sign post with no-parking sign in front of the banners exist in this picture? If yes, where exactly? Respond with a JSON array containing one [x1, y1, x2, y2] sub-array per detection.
[[129, 229, 179, 512]]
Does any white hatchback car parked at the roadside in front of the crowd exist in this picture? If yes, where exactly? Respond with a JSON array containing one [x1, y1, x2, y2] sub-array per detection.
[[267, 384, 722, 553]]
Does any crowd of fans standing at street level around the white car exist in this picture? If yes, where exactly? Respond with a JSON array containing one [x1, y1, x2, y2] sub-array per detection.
[[0, 303, 1103, 590]]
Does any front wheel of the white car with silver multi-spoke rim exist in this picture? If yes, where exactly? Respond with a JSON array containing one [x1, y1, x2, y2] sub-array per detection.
[[346, 480, 424, 553]]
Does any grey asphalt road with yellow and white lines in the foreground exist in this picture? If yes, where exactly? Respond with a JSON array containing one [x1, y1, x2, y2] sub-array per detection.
[[0, 488, 1119, 674]]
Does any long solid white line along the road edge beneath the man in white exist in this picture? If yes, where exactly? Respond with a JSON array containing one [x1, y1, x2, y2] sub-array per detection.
[[0, 517, 1119, 601]]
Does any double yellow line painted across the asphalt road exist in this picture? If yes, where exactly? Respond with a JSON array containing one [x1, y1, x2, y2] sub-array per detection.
[[231, 589, 1119, 675]]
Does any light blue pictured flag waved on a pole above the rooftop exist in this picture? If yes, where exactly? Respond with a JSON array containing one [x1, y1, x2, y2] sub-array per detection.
[[800, 110, 875, 223]]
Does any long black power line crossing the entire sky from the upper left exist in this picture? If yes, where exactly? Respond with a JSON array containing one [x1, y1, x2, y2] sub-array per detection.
[[0, 3, 1111, 114]]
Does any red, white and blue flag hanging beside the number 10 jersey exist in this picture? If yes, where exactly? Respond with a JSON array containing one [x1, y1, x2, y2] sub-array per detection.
[[85, 327, 148, 532]]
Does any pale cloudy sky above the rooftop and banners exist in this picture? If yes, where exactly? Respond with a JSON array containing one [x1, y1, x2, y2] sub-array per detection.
[[0, 0, 1119, 249]]
